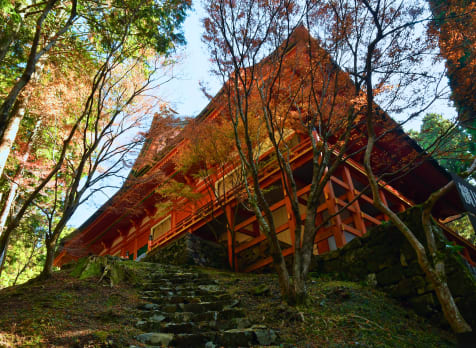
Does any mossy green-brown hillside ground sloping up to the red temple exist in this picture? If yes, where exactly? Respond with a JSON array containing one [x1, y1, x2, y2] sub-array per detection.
[[0, 261, 455, 347]]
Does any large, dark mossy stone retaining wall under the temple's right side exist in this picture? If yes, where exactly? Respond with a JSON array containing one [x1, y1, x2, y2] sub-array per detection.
[[312, 207, 476, 330]]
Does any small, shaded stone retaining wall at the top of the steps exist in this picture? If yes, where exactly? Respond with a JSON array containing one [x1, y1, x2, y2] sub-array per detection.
[[144, 233, 228, 269]]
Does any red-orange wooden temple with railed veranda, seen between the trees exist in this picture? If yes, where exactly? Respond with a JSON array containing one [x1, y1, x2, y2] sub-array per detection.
[[55, 29, 476, 272]]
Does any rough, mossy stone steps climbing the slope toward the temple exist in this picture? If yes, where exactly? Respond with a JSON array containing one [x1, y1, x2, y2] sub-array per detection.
[[130, 264, 278, 348]]
